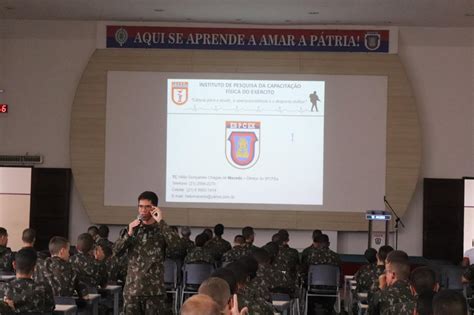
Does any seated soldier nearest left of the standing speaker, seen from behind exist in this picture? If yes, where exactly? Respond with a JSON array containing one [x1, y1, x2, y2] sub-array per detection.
[[70, 233, 107, 293]]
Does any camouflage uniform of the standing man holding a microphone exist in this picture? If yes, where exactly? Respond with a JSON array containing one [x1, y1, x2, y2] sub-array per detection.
[[114, 220, 179, 315]]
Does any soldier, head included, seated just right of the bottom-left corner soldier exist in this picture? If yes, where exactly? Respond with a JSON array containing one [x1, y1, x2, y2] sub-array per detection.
[[33, 236, 88, 297]]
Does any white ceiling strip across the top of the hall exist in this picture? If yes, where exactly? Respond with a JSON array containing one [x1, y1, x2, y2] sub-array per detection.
[[0, 0, 474, 27]]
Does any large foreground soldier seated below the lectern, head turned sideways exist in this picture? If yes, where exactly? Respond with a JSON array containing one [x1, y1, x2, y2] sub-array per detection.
[[369, 250, 415, 315]]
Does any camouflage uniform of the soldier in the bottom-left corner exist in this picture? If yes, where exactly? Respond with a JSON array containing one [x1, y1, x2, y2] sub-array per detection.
[[0, 279, 54, 314]]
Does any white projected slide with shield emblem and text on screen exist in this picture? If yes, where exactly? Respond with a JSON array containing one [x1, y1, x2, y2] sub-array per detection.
[[166, 78, 325, 205]]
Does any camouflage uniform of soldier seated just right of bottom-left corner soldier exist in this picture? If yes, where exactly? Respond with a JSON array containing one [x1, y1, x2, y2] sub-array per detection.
[[34, 257, 88, 297]]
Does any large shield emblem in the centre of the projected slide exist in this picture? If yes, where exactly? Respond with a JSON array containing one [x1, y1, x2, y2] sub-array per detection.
[[225, 121, 261, 169]]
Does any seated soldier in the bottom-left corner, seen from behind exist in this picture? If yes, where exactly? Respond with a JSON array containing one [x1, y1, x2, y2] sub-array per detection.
[[0, 247, 54, 314]]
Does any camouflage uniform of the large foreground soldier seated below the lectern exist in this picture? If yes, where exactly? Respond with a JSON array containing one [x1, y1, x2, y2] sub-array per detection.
[[369, 280, 415, 315]]
